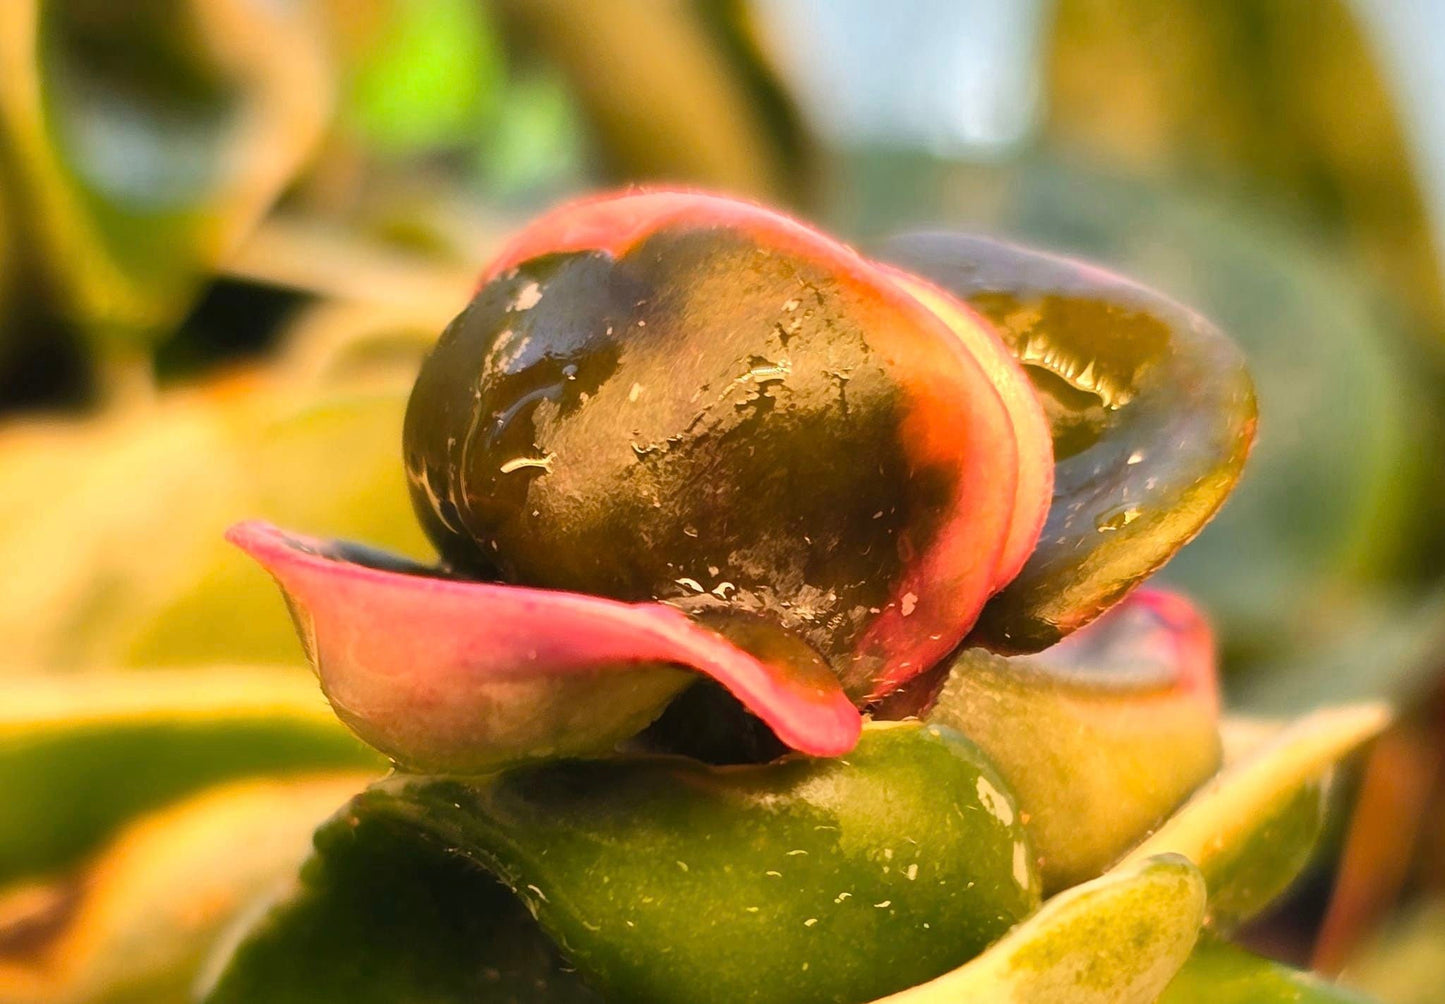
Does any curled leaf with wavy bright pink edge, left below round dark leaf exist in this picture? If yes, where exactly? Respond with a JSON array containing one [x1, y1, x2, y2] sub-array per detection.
[[227, 522, 861, 771]]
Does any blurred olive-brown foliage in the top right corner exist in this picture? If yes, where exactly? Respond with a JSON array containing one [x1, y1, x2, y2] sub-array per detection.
[[1046, 0, 1445, 349]]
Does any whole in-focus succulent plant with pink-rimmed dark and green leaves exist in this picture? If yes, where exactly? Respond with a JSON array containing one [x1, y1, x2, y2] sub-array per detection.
[[199, 191, 1387, 1004]]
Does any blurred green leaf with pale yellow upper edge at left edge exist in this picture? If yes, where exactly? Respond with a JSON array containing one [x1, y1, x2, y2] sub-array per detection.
[[0, 669, 384, 883]]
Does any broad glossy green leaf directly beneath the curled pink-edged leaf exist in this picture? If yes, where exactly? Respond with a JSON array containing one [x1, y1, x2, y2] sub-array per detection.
[[200, 722, 1039, 1004]]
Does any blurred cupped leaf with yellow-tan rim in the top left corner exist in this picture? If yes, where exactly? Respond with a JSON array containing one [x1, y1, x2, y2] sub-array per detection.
[[0, 0, 331, 347]]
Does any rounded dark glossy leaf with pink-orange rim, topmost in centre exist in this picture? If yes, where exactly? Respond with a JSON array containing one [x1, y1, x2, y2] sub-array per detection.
[[405, 191, 1049, 699]]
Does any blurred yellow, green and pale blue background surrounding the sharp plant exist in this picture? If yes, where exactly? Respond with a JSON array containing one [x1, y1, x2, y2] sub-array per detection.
[[0, 0, 1445, 1004]]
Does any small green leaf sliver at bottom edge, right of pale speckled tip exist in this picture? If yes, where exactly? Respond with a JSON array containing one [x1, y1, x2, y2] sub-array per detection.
[[1159, 938, 1371, 1004]]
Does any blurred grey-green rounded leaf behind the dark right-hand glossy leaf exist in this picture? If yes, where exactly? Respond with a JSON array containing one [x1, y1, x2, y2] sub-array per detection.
[[873, 155, 1421, 658]]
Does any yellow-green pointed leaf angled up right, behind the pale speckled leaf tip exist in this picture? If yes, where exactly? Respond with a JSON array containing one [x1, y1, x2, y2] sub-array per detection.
[[1124, 704, 1390, 927]]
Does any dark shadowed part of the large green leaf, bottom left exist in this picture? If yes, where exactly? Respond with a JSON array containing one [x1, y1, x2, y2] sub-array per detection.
[[201, 785, 601, 1004]]
